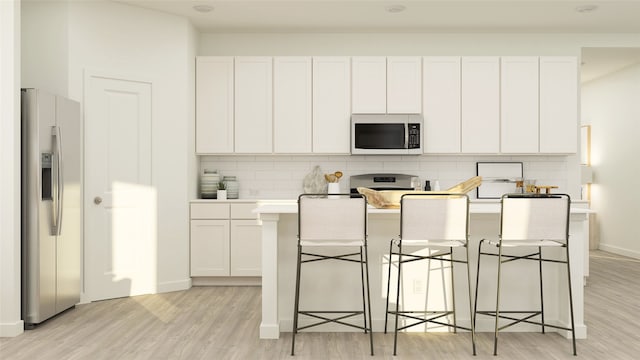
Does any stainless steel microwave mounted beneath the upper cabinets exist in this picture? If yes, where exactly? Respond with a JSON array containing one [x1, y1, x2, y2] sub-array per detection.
[[351, 114, 423, 155]]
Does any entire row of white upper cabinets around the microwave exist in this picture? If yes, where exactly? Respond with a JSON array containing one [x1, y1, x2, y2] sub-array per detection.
[[195, 56, 578, 154]]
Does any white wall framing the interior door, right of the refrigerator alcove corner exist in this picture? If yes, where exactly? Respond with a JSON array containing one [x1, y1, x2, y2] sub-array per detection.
[[68, 2, 194, 292]]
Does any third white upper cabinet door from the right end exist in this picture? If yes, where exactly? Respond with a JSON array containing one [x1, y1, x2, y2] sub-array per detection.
[[462, 56, 500, 153]]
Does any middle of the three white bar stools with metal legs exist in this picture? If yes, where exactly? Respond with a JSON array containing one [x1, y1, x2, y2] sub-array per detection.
[[384, 193, 476, 355]]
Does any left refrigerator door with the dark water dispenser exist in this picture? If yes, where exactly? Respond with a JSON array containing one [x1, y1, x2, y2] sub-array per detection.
[[22, 89, 56, 323]]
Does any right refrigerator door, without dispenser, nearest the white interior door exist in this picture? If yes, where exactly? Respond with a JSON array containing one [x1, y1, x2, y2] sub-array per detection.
[[56, 96, 82, 312]]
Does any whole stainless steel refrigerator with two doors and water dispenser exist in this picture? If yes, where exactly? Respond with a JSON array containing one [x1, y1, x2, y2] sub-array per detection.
[[21, 89, 82, 328]]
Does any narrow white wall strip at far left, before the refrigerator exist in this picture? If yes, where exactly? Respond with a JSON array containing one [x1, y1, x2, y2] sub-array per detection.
[[0, 0, 24, 337]]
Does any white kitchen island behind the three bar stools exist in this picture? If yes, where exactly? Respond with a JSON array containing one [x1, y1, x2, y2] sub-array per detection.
[[254, 200, 591, 339]]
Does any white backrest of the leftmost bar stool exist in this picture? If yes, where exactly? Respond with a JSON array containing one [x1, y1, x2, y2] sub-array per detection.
[[298, 194, 367, 242]]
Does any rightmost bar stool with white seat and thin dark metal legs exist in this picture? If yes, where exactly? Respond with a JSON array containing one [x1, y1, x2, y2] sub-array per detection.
[[474, 194, 576, 355]]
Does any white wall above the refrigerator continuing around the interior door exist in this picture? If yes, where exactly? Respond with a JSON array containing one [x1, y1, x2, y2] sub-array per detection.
[[23, 1, 197, 302]]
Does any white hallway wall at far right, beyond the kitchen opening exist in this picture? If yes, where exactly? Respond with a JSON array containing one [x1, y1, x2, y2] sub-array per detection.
[[582, 64, 640, 258]]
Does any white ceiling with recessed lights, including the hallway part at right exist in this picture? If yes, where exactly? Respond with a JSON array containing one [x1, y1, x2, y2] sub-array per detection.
[[113, 0, 640, 82]]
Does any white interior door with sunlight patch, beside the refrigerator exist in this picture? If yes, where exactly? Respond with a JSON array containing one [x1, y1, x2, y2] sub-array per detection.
[[84, 74, 157, 301]]
